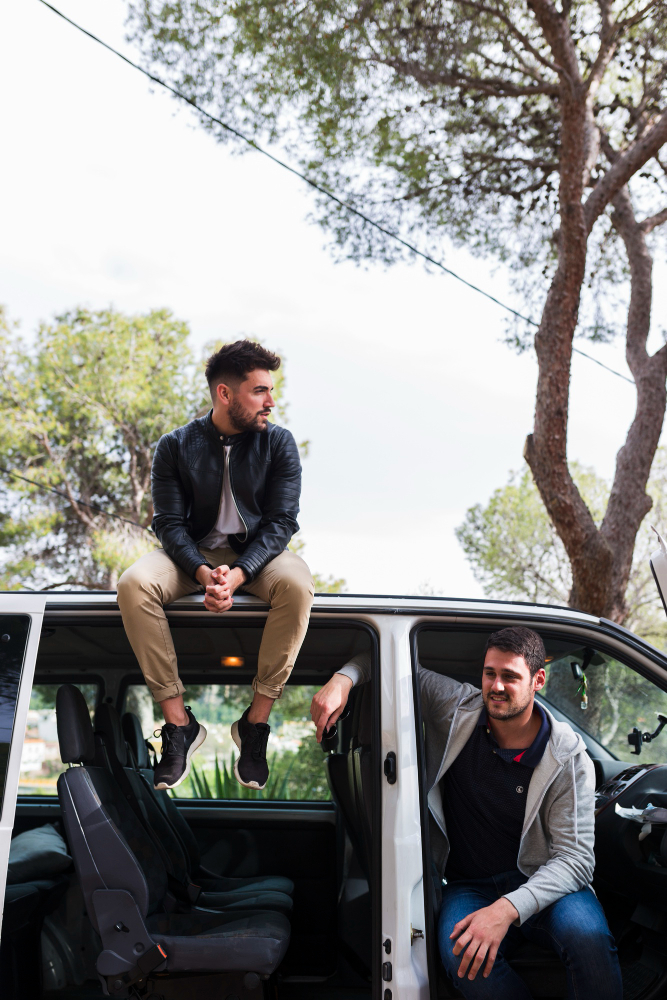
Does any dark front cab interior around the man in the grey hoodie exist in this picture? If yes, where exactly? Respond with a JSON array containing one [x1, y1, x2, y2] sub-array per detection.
[[413, 626, 667, 1000]]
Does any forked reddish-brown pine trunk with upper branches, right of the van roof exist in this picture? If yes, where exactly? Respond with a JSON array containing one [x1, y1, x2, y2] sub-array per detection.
[[524, 11, 667, 621]]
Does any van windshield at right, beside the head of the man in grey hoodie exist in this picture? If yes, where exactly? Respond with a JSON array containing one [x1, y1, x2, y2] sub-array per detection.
[[541, 641, 667, 764]]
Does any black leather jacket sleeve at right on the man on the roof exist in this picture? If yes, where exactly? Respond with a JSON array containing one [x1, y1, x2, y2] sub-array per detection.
[[232, 428, 301, 581]]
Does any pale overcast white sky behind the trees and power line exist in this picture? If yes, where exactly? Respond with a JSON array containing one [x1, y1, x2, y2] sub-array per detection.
[[0, 0, 667, 597]]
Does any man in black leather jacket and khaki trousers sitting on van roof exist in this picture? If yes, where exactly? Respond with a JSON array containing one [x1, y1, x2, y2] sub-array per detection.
[[118, 340, 313, 788]]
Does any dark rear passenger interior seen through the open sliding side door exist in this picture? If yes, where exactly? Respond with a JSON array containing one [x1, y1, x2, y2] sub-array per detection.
[[0, 615, 381, 1000]]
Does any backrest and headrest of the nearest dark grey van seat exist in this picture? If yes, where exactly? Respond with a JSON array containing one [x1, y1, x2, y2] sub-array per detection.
[[56, 684, 167, 931]]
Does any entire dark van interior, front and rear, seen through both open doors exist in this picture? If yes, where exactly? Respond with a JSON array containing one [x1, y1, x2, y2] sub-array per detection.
[[0, 613, 667, 1000]]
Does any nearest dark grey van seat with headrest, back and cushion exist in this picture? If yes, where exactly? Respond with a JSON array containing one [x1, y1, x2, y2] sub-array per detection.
[[56, 684, 290, 1000]]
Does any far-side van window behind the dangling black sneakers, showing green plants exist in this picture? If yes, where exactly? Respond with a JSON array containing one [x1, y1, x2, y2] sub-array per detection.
[[124, 682, 330, 802]]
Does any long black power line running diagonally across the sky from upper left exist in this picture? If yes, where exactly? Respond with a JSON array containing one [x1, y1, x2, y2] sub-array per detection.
[[39, 0, 634, 385]]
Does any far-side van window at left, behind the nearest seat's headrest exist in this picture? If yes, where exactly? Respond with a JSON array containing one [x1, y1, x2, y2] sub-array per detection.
[[19, 682, 100, 795]]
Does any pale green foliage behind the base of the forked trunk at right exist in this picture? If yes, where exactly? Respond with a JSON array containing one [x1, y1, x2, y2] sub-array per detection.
[[456, 458, 667, 647]]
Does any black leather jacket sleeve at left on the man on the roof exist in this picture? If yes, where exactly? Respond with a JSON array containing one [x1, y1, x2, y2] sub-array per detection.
[[151, 435, 210, 581]]
